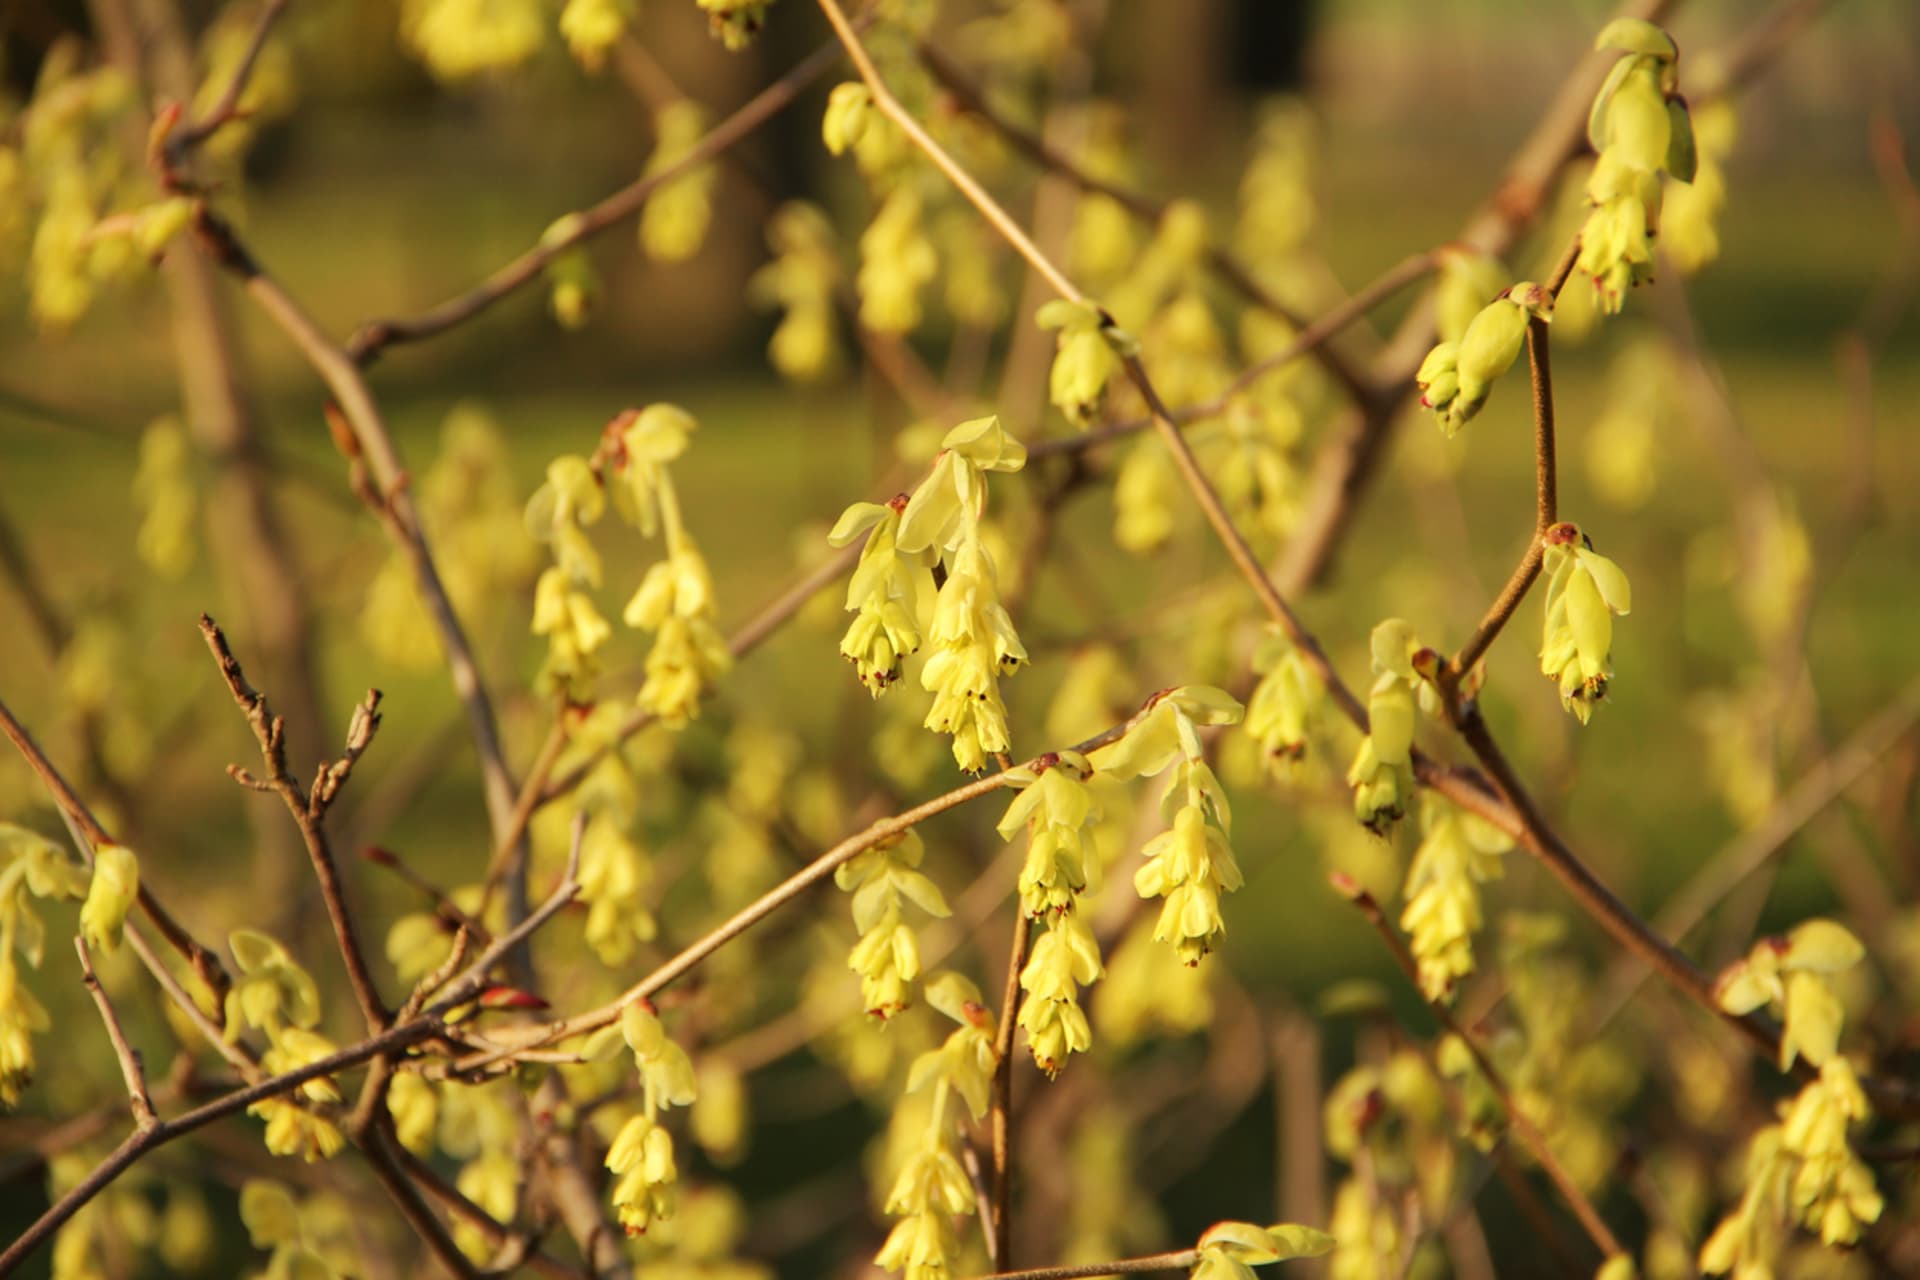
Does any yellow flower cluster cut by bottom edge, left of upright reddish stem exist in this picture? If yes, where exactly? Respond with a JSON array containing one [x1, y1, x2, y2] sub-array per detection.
[[874, 973, 998, 1280]]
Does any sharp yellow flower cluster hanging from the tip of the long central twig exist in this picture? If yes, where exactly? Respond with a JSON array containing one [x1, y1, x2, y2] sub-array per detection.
[[1091, 685, 1242, 965]]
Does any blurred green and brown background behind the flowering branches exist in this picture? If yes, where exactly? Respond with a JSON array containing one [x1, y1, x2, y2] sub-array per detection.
[[0, 0, 1920, 1276]]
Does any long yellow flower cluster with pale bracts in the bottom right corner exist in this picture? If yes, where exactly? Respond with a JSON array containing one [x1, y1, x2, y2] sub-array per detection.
[[1699, 919, 1885, 1276]]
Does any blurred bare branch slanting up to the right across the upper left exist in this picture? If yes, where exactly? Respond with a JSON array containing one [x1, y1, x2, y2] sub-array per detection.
[[348, 40, 835, 365]]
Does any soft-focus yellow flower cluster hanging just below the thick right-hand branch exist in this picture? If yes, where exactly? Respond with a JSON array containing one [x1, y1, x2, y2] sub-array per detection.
[[1400, 798, 1513, 1000]]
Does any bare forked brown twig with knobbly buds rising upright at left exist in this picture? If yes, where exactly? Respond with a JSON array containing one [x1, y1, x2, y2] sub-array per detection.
[[200, 614, 388, 1032]]
